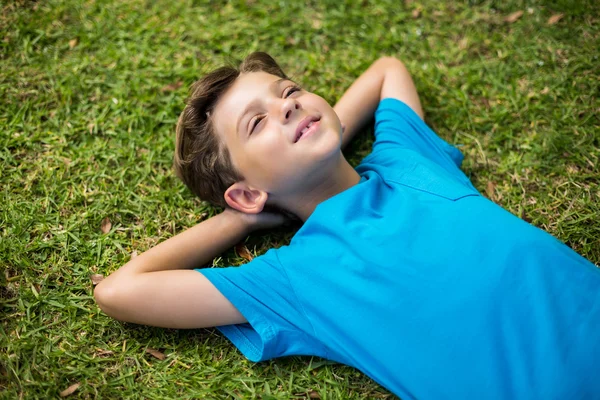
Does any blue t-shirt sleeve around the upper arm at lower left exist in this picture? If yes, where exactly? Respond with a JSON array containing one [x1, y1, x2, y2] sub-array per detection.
[[197, 250, 325, 362]]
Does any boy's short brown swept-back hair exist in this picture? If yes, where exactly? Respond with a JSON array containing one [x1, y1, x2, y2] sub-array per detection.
[[173, 52, 287, 207]]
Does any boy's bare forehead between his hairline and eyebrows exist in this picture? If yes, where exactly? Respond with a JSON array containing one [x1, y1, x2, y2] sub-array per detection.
[[215, 71, 282, 137]]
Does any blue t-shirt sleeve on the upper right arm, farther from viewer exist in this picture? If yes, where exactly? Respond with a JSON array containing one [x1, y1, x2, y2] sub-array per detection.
[[373, 98, 463, 175]]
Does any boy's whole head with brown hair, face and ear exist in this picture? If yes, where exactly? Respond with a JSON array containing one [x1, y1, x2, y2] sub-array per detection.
[[174, 53, 341, 213]]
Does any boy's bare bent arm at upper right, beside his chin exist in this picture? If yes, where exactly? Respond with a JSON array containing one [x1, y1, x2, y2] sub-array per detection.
[[333, 57, 423, 147]]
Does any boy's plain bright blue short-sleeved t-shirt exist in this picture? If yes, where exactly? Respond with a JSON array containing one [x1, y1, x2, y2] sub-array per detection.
[[199, 99, 600, 399]]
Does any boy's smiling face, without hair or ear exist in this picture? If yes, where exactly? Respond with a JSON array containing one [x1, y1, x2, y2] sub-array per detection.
[[214, 72, 342, 195]]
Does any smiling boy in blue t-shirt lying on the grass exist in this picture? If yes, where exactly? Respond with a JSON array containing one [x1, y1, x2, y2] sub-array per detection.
[[95, 53, 600, 399]]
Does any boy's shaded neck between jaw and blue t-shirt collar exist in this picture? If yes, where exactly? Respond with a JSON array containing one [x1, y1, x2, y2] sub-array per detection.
[[278, 152, 360, 222]]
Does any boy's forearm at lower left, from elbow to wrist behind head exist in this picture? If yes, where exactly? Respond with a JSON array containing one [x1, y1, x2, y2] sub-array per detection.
[[117, 211, 249, 273]]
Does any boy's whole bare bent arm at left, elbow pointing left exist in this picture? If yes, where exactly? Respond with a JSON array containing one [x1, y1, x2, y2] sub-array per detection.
[[94, 209, 283, 328]]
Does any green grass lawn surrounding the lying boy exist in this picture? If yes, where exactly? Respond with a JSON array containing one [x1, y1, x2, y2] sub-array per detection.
[[0, 0, 600, 399]]
